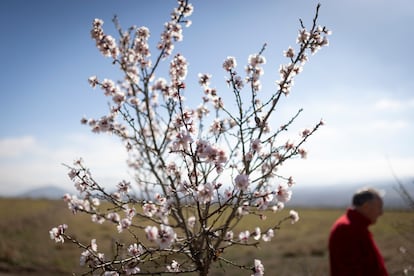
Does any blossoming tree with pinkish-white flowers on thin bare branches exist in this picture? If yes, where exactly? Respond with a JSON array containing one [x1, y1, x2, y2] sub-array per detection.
[[50, 0, 329, 275]]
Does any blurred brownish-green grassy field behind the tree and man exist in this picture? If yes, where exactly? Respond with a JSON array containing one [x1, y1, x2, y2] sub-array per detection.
[[0, 199, 414, 276]]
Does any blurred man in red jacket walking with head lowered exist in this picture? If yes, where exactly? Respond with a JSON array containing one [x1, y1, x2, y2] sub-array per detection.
[[329, 188, 388, 276]]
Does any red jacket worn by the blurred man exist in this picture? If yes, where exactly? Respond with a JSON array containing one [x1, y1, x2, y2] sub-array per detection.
[[329, 209, 388, 276]]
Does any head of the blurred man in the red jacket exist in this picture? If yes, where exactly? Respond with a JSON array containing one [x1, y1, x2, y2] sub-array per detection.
[[352, 188, 383, 223]]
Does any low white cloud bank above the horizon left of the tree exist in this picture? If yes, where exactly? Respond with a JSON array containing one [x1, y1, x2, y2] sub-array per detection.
[[0, 134, 128, 195]]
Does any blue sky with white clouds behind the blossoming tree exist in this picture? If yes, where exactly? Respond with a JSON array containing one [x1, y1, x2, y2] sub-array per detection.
[[0, 0, 414, 195]]
